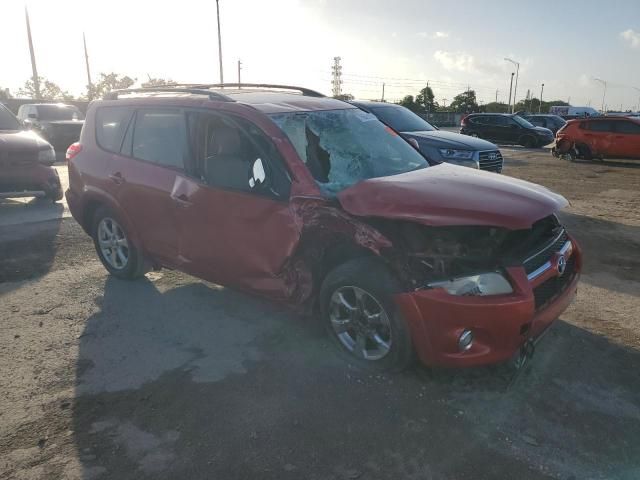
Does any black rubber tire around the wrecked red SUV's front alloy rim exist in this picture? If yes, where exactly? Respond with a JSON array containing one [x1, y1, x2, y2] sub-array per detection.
[[319, 257, 413, 372]]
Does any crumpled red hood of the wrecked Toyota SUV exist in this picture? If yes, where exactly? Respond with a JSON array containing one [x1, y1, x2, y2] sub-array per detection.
[[338, 164, 568, 230]]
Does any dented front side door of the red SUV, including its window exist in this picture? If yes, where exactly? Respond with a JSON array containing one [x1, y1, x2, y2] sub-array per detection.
[[171, 114, 300, 299]]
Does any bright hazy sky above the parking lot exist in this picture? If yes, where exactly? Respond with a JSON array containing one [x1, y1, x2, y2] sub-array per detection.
[[0, 0, 640, 110]]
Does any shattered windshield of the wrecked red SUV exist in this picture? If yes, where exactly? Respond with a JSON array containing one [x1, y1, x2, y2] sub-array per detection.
[[270, 108, 429, 195]]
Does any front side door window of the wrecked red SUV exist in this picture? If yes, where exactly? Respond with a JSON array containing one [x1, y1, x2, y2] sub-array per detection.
[[189, 112, 290, 198]]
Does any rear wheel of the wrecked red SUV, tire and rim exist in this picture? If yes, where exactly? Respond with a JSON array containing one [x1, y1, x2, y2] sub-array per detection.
[[93, 208, 144, 280]]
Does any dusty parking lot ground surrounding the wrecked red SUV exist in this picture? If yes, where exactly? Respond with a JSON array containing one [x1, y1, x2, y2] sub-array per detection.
[[0, 149, 640, 480]]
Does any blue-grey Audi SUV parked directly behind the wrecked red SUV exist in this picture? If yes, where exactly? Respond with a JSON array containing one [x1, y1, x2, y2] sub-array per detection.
[[350, 101, 503, 173]]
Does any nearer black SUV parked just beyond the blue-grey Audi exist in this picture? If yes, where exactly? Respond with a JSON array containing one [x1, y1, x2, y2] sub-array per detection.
[[460, 113, 554, 148]]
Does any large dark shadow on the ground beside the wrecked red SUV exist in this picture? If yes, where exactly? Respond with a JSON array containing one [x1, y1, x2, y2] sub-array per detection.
[[72, 273, 640, 479]]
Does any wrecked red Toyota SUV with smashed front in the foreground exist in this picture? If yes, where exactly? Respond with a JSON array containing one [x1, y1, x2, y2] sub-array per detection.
[[66, 84, 582, 370]]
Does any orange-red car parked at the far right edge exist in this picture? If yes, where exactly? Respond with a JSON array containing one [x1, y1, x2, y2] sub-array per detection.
[[554, 117, 640, 159]]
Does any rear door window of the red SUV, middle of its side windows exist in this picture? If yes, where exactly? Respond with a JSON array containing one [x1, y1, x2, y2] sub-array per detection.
[[131, 109, 187, 169]]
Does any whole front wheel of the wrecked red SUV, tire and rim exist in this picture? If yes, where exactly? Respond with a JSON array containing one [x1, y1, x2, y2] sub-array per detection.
[[320, 257, 413, 371]]
